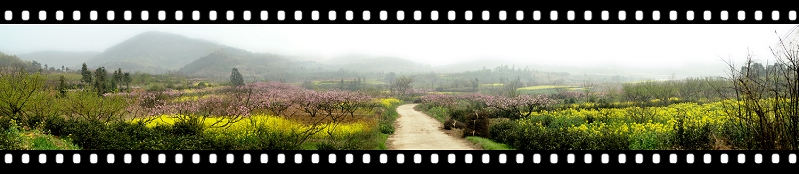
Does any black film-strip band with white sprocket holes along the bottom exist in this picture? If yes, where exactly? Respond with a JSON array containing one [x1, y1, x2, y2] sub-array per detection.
[[0, 150, 797, 166]]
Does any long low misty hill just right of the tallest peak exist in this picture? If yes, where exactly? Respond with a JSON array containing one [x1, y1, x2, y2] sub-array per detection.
[[178, 48, 440, 81]]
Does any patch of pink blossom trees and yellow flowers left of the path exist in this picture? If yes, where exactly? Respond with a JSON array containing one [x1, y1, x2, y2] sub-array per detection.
[[113, 82, 384, 149]]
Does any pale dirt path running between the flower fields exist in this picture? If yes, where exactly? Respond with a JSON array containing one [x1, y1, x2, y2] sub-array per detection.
[[388, 104, 477, 150]]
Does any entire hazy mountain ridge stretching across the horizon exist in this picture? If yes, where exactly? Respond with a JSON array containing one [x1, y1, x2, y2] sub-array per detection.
[[10, 31, 732, 81]]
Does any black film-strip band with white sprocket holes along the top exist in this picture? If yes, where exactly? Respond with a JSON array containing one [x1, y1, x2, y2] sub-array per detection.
[[0, 7, 799, 24]]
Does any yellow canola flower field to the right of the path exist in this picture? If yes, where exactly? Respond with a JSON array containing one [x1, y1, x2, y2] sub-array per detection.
[[517, 98, 787, 150]]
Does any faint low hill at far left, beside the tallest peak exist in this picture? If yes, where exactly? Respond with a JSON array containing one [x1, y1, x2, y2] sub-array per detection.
[[17, 51, 100, 69]]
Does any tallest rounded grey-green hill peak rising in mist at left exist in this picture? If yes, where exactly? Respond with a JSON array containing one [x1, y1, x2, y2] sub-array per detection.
[[86, 31, 226, 73]]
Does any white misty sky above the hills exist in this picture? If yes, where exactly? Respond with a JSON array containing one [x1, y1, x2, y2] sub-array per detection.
[[0, 24, 796, 67]]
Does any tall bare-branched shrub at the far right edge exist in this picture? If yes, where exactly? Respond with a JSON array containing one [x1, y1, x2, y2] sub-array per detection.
[[716, 26, 799, 150]]
